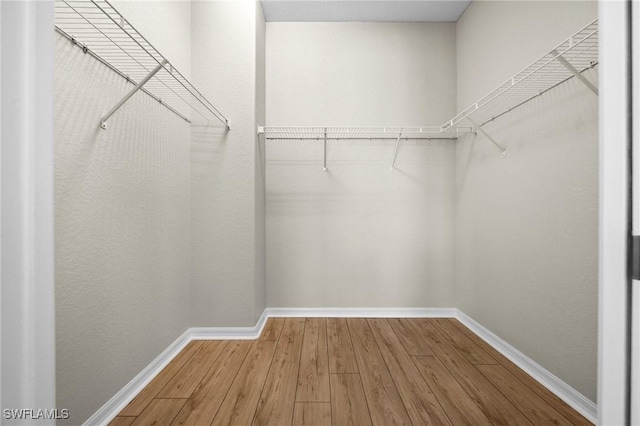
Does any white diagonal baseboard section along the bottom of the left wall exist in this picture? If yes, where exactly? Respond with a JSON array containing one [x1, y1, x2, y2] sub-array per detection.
[[83, 330, 191, 426]]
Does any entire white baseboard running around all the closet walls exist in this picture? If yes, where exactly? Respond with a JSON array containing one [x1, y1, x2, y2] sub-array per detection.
[[84, 308, 597, 426]]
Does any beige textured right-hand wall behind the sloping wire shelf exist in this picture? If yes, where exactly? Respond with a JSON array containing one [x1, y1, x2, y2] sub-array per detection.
[[456, 1, 598, 401]]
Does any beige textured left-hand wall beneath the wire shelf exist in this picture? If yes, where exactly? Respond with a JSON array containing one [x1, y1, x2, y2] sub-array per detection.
[[55, 3, 191, 425]]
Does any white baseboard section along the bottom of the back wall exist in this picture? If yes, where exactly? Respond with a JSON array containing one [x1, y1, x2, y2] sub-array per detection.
[[266, 308, 457, 318]]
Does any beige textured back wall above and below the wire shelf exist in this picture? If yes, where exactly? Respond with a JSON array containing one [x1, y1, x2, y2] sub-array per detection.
[[266, 23, 456, 307]]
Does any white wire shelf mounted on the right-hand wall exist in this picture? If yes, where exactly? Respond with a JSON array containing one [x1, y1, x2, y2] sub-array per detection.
[[441, 19, 598, 131]]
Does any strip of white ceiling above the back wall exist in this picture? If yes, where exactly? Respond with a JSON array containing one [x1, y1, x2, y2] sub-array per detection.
[[261, 0, 471, 22]]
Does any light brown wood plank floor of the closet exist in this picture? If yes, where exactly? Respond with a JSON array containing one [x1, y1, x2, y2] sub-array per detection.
[[111, 318, 590, 426]]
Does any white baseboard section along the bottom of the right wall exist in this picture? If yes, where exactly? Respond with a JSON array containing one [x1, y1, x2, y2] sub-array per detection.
[[456, 310, 598, 424]]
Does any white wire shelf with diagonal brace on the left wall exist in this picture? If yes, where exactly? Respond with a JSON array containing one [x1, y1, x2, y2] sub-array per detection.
[[55, 0, 229, 130]]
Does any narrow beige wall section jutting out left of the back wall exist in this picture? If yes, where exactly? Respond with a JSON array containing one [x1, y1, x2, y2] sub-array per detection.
[[191, 0, 264, 326]]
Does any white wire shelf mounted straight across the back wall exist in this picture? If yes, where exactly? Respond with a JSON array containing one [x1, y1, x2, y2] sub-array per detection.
[[258, 126, 472, 140]]
